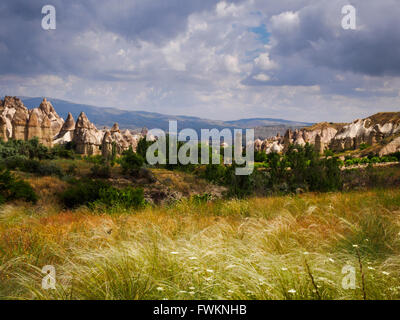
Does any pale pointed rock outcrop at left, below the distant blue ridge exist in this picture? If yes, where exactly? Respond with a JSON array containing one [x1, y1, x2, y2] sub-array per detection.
[[0, 96, 155, 156]]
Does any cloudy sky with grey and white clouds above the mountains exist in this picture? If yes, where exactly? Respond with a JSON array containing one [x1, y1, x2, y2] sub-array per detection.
[[0, 0, 400, 122]]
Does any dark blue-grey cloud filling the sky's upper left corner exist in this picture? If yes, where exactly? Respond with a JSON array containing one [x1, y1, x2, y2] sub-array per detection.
[[0, 0, 240, 77]]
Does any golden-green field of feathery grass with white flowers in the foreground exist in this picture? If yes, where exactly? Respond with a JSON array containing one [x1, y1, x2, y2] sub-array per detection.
[[0, 182, 400, 299]]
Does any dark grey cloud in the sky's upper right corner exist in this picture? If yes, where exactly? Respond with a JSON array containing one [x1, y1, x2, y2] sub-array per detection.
[[271, 0, 400, 82]]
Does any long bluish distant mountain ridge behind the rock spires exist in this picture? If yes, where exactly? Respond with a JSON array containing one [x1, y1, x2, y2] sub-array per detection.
[[20, 97, 311, 138]]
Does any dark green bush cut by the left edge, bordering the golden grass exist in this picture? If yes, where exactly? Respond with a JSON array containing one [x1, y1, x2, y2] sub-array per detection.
[[0, 170, 38, 203]]
